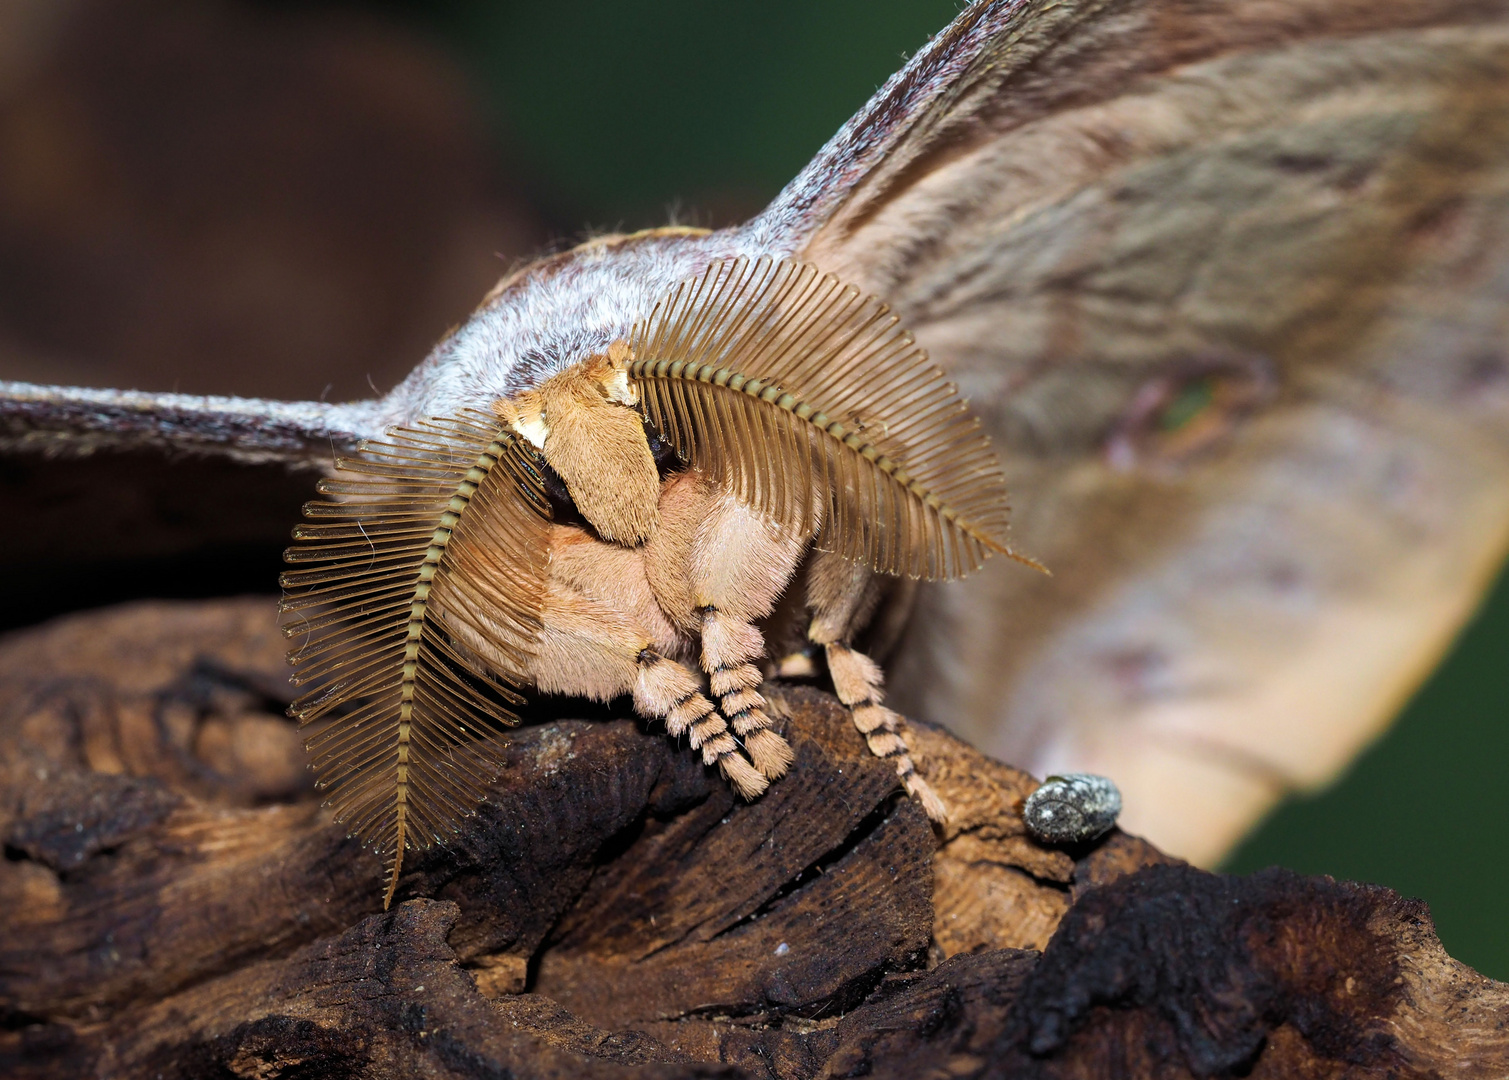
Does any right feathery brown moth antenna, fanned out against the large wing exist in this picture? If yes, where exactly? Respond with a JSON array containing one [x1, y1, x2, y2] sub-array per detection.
[[629, 258, 1013, 578]]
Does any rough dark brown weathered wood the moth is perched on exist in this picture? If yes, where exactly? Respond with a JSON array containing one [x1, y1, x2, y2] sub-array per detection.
[[0, 599, 1509, 1080]]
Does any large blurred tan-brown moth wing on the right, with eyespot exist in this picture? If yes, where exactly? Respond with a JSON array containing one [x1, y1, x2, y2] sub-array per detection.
[[751, 0, 1509, 861]]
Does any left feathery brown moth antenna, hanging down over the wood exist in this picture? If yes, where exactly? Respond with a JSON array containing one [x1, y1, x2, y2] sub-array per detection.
[[282, 412, 549, 907]]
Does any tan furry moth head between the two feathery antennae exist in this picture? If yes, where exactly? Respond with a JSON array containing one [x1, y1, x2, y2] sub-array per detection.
[[493, 341, 659, 546]]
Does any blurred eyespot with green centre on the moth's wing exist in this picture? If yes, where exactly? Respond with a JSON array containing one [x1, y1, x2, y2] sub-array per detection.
[[1106, 357, 1277, 472]]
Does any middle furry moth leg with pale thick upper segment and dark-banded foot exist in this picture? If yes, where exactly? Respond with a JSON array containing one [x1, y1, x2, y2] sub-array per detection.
[[679, 492, 806, 780]]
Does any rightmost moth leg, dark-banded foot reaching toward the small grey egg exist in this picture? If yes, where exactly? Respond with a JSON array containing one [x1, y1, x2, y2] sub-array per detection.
[[807, 552, 948, 822]]
